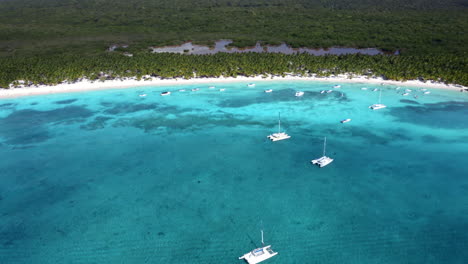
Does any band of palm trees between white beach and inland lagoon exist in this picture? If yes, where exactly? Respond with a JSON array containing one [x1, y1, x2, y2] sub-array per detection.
[[0, 52, 468, 88]]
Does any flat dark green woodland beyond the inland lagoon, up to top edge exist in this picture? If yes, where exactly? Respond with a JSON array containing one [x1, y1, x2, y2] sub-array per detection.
[[0, 0, 468, 57]]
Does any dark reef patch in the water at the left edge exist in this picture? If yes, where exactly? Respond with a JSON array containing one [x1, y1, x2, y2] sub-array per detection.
[[0, 106, 93, 144]]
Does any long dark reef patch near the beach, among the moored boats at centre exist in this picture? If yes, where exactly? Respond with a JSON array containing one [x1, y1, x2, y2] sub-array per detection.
[[217, 89, 349, 108]]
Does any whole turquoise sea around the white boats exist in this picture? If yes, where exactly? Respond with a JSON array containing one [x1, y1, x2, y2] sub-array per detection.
[[0, 81, 468, 264]]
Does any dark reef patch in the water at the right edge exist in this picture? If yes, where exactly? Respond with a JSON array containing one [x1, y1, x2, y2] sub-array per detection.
[[390, 101, 468, 129]]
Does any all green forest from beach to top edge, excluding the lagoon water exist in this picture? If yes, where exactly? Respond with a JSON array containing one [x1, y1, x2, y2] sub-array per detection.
[[0, 0, 468, 88]]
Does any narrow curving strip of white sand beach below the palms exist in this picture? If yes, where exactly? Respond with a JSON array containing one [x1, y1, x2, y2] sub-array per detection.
[[0, 75, 468, 99]]
